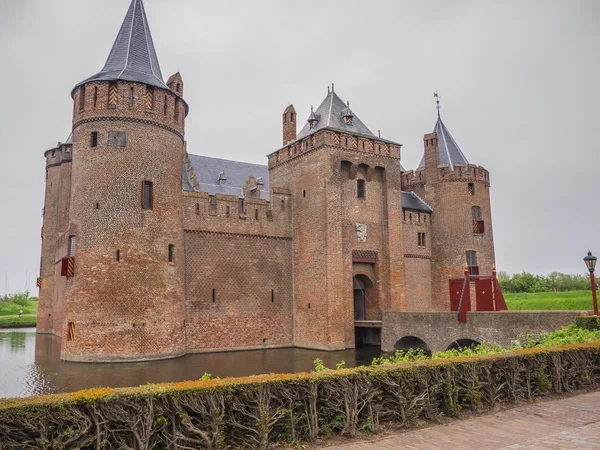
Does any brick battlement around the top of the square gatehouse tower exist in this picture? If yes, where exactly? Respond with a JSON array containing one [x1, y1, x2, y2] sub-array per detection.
[[268, 129, 402, 169]]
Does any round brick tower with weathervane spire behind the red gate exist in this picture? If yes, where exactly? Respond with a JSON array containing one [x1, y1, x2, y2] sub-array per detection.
[[402, 99, 495, 311]]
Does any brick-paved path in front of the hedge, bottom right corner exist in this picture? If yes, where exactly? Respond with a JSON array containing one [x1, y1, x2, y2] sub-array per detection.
[[328, 392, 600, 450]]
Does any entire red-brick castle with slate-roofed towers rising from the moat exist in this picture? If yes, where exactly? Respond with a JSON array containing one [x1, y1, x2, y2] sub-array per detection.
[[37, 0, 494, 362]]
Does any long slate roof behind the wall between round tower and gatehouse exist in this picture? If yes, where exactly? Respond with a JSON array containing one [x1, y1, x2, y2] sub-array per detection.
[[183, 154, 270, 201]]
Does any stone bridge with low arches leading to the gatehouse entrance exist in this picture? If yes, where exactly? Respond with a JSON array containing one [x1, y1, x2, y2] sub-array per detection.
[[381, 311, 588, 353]]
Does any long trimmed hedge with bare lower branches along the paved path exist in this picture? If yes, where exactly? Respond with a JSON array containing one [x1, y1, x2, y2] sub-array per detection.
[[0, 343, 600, 450]]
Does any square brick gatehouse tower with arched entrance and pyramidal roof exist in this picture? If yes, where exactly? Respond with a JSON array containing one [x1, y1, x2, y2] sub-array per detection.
[[269, 89, 406, 350]]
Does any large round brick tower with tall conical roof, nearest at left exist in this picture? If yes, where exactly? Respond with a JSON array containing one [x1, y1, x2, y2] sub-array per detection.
[[55, 0, 188, 361]]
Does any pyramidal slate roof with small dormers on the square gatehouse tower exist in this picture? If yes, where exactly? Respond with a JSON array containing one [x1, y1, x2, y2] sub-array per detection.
[[297, 89, 375, 139]]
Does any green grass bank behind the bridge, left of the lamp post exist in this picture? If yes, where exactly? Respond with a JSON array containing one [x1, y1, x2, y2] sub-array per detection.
[[504, 291, 594, 311]]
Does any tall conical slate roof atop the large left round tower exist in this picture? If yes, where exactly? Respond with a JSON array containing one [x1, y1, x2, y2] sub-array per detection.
[[75, 0, 169, 93]]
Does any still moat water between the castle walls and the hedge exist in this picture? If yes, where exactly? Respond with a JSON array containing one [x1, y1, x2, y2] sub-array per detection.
[[0, 328, 380, 398]]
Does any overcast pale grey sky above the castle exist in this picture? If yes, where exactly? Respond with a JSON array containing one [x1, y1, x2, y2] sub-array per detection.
[[0, 0, 600, 294]]
